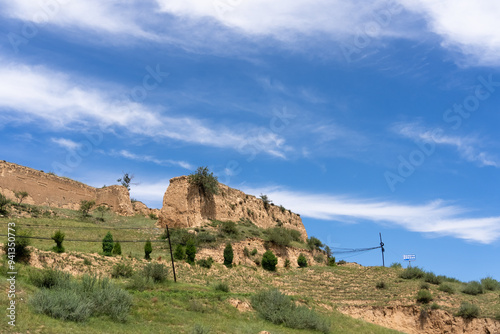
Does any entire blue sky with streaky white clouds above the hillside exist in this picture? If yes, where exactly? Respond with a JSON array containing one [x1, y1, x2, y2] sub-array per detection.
[[0, 0, 500, 280]]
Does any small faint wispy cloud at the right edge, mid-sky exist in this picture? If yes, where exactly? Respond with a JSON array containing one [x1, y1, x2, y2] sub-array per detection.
[[393, 123, 500, 167]]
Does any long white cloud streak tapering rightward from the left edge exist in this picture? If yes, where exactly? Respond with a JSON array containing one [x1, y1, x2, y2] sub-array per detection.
[[0, 62, 291, 158]]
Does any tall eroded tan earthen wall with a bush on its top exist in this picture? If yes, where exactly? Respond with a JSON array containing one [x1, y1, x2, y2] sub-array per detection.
[[158, 176, 307, 238]]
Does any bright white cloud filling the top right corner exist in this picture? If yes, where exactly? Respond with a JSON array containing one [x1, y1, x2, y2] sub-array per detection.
[[399, 0, 500, 65]]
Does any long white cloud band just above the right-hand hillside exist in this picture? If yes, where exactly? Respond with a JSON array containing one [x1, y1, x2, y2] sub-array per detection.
[[240, 187, 500, 244]]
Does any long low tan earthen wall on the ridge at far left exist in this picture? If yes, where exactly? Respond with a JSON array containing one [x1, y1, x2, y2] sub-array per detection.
[[0, 161, 134, 216]]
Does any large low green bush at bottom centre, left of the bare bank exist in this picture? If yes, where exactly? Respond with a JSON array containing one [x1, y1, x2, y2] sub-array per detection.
[[251, 289, 330, 333]]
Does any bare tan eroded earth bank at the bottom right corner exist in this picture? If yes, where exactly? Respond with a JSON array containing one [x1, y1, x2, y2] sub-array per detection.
[[339, 306, 500, 334]]
